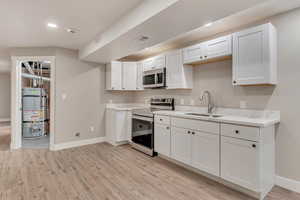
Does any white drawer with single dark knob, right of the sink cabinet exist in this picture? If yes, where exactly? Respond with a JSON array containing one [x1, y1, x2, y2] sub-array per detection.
[[221, 124, 259, 141]]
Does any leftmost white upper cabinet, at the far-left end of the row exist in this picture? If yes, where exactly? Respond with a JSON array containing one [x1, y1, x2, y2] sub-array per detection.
[[106, 61, 122, 90]]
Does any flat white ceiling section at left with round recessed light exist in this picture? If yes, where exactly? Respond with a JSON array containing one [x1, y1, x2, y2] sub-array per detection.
[[0, 0, 143, 49]]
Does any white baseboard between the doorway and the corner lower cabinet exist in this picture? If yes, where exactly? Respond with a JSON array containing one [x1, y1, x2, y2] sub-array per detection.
[[50, 137, 106, 151]]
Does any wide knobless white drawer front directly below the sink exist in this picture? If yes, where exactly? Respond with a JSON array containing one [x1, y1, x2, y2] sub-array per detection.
[[171, 117, 219, 134]]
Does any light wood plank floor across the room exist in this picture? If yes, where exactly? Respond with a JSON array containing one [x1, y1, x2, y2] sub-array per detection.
[[0, 138, 300, 200]]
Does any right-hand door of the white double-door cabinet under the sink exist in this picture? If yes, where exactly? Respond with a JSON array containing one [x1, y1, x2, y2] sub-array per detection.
[[191, 131, 220, 176]]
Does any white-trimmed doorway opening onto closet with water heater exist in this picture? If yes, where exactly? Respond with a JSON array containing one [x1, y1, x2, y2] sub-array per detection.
[[11, 57, 55, 149]]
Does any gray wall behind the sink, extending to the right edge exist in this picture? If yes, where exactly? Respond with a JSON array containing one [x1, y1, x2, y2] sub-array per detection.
[[135, 9, 300, 181]]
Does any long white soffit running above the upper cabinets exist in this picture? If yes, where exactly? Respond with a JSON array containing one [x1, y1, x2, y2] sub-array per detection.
[[80, 0, 300, 63]]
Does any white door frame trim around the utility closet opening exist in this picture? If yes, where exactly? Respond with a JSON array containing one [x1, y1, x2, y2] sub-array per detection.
[[10, 56, 56, 150]]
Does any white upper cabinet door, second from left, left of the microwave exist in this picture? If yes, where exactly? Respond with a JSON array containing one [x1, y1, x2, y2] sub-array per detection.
[[122, 62, 137, 90]]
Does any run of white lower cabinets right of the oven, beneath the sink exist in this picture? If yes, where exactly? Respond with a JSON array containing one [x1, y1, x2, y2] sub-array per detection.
[[155, 115, 275, 200]]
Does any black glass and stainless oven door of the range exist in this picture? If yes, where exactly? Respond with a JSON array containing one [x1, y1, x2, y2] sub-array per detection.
[[131, 115, 154, 150]]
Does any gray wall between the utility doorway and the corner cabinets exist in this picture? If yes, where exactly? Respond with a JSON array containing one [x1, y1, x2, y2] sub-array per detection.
[[11, 48, 133, 144]]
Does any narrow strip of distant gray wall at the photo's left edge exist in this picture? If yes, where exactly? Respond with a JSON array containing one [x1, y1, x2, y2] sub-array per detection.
[[0, 73, 10, 118]]
